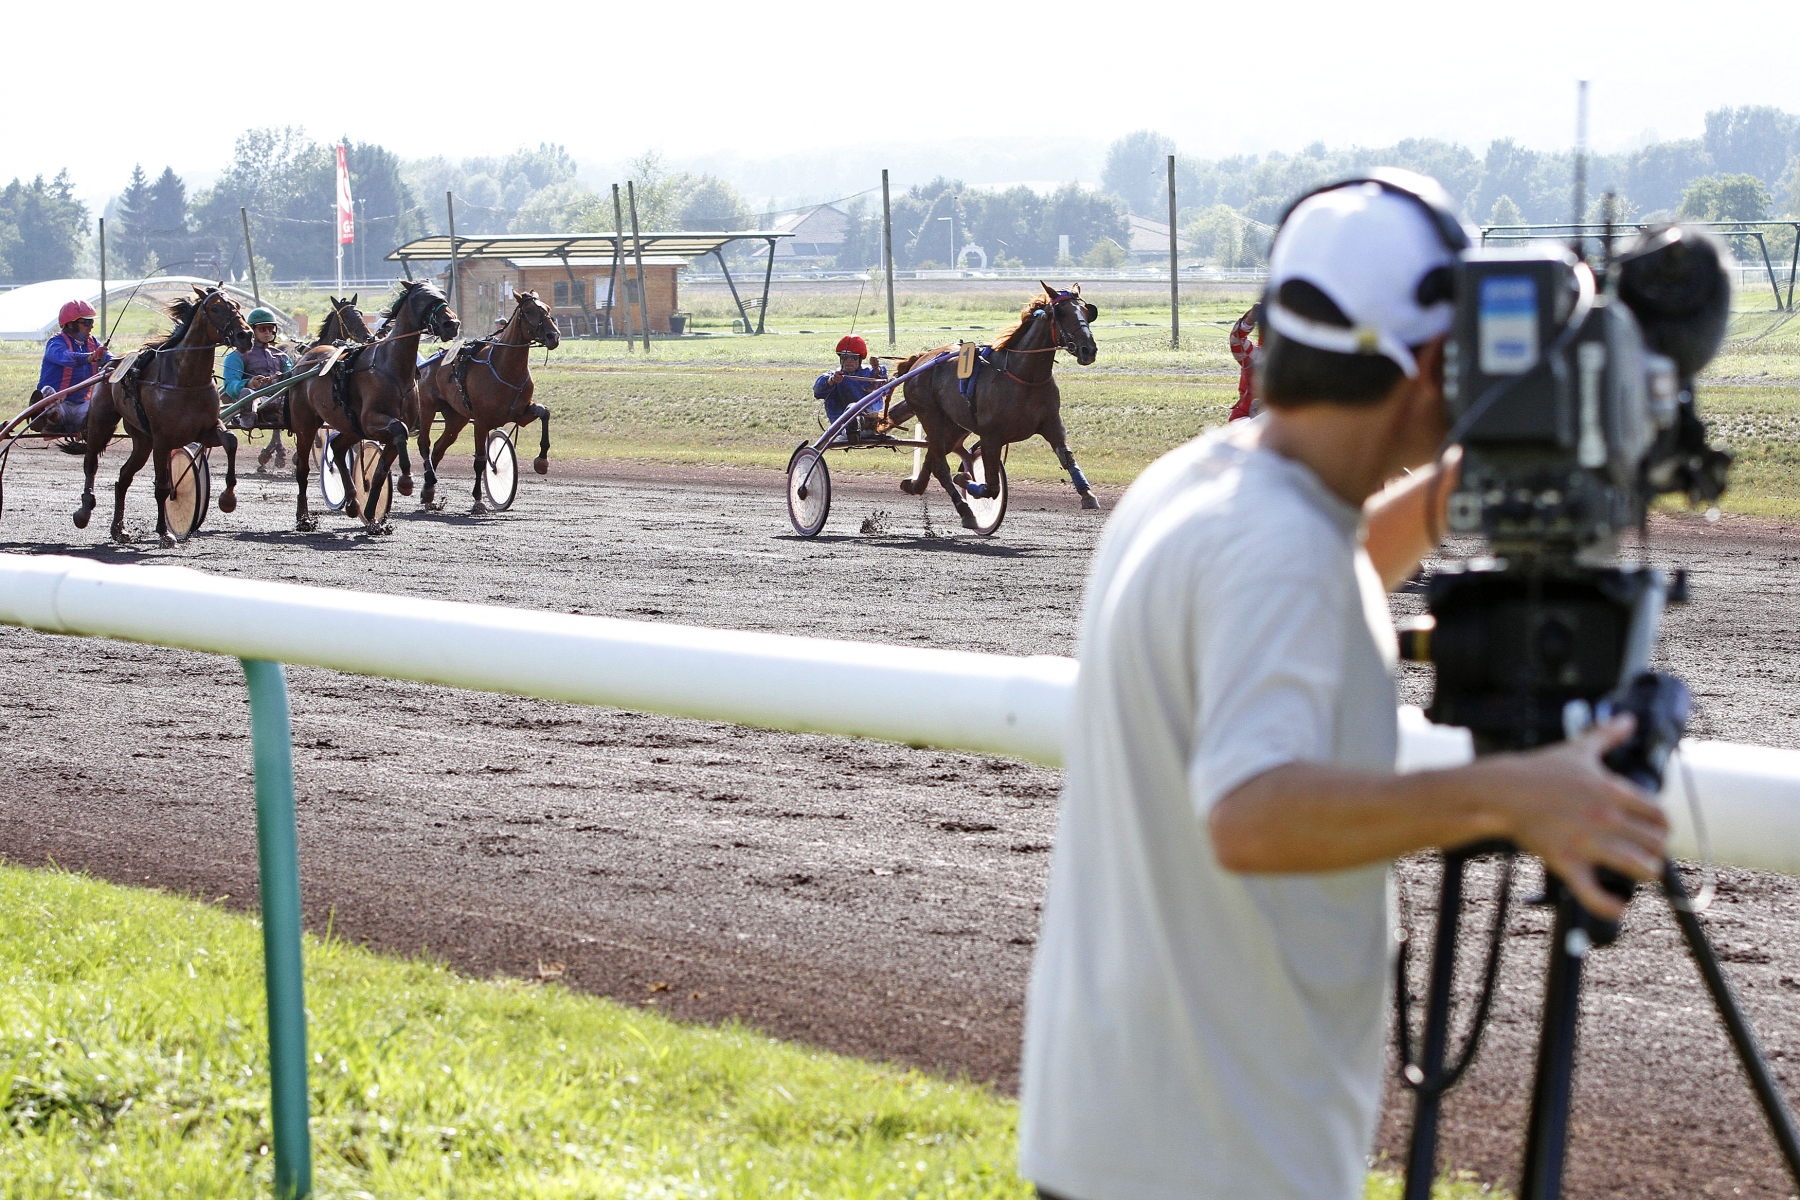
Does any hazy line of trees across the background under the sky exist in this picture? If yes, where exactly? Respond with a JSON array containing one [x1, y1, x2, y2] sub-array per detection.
[[0, 106, 1800, 282]]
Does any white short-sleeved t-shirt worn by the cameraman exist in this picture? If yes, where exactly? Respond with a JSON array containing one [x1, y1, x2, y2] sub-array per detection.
[[1019, 419, 1397, 1200]]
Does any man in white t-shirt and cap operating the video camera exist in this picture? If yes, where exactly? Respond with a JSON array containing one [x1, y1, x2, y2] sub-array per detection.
[[1021, 173, 1667, 1200]]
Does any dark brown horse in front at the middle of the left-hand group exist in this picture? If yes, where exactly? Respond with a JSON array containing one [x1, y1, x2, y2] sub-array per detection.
[[290, 279, 461, 533]]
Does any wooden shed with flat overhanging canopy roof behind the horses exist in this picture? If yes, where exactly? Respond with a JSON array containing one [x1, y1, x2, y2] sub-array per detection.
[[387, 230, 794, 344]]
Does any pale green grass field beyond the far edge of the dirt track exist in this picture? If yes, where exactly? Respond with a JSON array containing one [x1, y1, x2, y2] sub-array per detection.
[[0, 284, 1800, 518]]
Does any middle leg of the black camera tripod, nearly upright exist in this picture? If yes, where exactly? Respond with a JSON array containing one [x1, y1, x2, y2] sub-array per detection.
[[1519, 874, 1593, 1200]]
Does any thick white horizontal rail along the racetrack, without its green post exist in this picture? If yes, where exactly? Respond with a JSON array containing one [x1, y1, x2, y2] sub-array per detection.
[[0, 554, 1800, 874]]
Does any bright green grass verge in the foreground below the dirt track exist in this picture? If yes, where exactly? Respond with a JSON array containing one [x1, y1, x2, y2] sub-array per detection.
[[0, 867, 1492, 1200]]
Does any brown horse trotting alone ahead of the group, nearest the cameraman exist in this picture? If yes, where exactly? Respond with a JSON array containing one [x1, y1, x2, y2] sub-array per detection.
[[889, 281, 1100, 529]]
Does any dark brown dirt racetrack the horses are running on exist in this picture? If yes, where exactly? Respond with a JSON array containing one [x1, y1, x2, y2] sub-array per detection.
[[0, 452, 1800, 1196]]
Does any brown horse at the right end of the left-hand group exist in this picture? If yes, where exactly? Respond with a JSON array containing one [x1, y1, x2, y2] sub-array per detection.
[[419, 291, 562, 513]]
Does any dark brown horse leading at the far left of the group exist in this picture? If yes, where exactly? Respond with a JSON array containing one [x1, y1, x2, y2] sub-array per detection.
[[74, 284, 254, 547]]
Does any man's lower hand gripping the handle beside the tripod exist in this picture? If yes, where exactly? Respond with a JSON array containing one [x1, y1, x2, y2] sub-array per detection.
[[1469, 716, 1669, 921]]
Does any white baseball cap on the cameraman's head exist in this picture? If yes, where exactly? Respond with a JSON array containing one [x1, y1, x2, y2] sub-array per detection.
[[1264, 167, 1469, 378]]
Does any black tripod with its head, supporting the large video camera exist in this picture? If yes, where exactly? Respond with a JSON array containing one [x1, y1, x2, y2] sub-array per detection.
[[1395, 569, 1800, 1200]]
